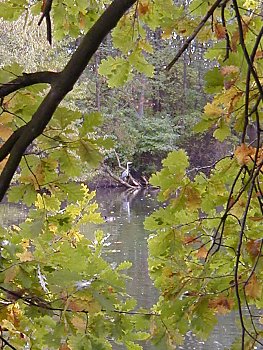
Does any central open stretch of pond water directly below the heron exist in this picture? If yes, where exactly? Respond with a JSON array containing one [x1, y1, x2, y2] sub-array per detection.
[[97, 189, 157, 307]]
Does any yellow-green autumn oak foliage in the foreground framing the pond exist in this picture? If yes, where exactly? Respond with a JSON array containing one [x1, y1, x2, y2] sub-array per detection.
[[0, 0, 263, 349]]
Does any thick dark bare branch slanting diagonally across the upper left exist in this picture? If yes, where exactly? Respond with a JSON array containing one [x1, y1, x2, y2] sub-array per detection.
[[0, 0, 136, 200]]
